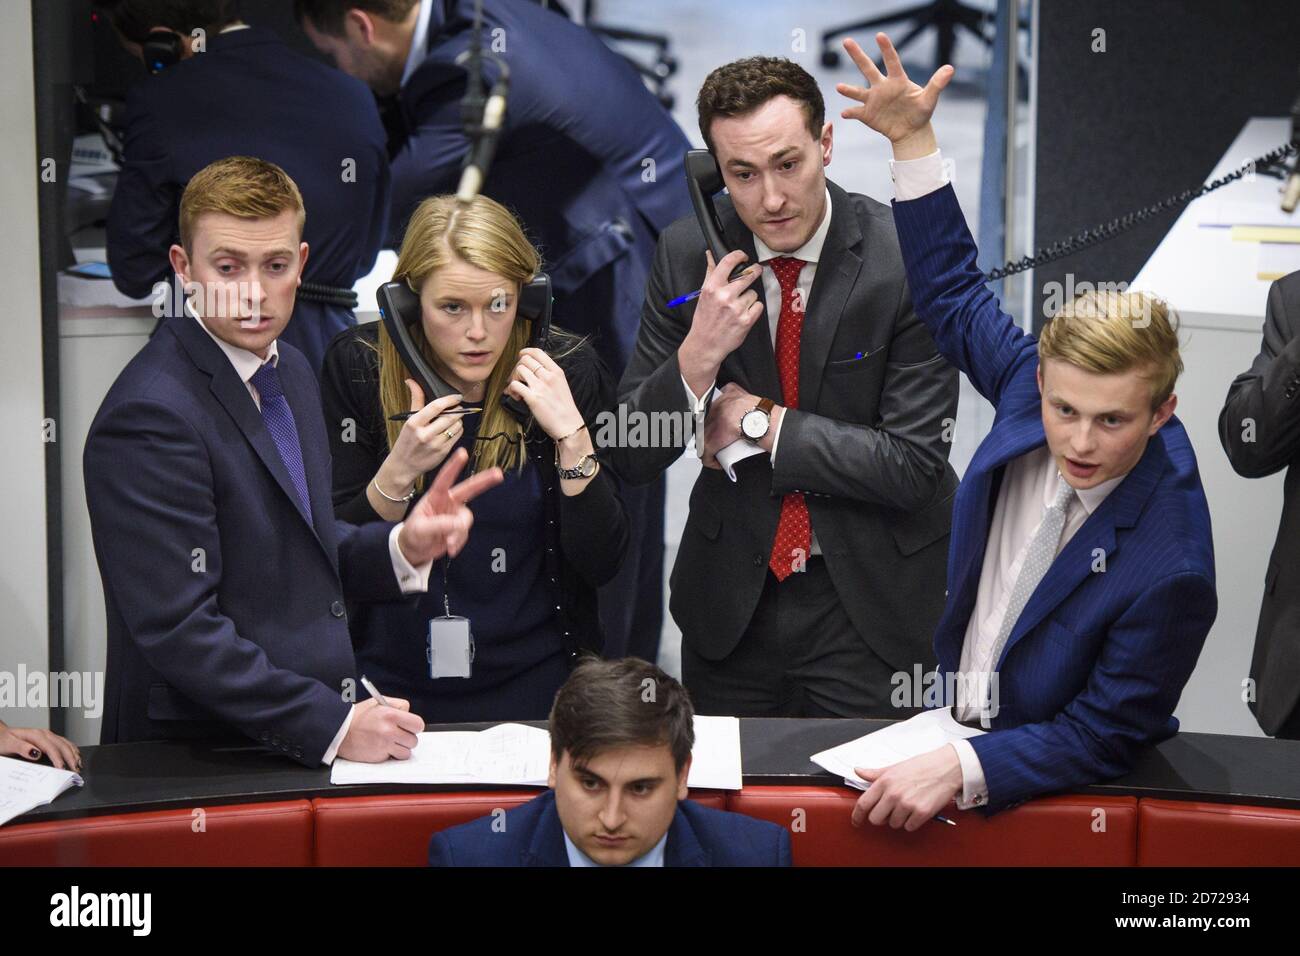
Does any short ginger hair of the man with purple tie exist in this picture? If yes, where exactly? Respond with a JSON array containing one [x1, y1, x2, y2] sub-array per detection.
[[181, 156, 307, 252]]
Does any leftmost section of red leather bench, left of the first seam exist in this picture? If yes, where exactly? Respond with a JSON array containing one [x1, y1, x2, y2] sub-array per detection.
[[0, 800, 313, 866]]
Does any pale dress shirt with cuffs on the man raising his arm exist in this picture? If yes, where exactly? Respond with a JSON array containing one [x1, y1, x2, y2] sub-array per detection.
[[889, 150, 1125, 810]]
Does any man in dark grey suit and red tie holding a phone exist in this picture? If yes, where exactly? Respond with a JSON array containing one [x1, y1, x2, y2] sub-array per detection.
[[614, 57, 957, 717]]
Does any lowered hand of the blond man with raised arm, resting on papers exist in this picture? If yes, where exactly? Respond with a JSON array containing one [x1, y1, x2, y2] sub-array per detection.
[[853, 744, 962, 831]]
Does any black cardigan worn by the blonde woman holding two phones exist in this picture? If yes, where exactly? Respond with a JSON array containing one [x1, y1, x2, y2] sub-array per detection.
[[321, 323, 628, 658]]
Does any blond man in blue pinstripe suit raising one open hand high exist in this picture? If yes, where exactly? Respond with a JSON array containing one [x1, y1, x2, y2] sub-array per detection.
[[837, 34, 1218, 830]]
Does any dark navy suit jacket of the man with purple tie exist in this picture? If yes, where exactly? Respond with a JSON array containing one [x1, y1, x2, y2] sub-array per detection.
[[83, 316, 400, 766]]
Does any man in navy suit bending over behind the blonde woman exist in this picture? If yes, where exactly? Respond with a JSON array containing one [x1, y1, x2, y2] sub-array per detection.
[[295, 0, 690, 659]]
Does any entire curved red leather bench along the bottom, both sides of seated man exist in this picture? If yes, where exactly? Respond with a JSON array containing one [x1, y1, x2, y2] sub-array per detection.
[[0, 786, 1300, 866]]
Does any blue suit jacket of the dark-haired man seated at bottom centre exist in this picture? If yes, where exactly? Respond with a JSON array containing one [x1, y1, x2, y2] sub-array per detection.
[[429, 790, 790, 866]]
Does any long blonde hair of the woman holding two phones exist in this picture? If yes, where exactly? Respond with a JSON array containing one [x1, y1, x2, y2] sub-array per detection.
[[378, 195, 541, 485]]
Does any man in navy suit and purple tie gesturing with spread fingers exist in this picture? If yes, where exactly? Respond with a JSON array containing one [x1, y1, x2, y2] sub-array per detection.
[[85, 156, 501, 766]]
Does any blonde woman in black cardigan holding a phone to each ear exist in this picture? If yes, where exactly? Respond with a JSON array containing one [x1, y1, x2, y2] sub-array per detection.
[[321, 196, 628, 722]]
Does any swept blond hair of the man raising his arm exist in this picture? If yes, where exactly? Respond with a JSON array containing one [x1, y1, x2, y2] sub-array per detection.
[[1039, 289, 1183, 410]]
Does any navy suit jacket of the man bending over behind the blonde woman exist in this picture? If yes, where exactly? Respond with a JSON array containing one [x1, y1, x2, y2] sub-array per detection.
[[390, 0, 690, 372]]
